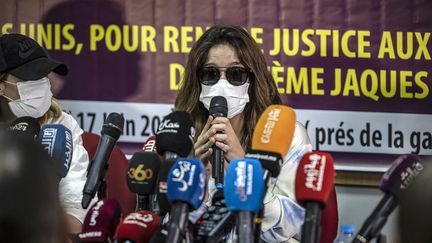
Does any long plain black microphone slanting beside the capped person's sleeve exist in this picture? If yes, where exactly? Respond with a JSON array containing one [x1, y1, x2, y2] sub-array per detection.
[[81, 112, 124, 208]]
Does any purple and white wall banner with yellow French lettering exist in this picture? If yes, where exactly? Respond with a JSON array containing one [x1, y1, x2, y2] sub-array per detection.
[[0, 0, 432, 169]]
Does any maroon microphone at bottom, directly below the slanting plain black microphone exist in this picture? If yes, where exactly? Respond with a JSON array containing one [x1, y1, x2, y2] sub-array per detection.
[[78, 198, 121, 242]]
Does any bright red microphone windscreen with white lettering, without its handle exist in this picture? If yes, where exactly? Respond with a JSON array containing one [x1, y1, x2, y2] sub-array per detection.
[[295, 151, 334, 207]]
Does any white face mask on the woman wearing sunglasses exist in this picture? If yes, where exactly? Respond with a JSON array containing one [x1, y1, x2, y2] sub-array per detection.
[[200, 79, 249, 119]]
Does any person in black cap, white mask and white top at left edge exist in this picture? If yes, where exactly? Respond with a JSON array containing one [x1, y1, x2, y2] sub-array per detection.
[[0, 34, 89, 233]]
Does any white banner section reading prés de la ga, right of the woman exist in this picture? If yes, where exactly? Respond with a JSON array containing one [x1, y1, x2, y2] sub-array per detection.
[[296, 110, 432, 155]]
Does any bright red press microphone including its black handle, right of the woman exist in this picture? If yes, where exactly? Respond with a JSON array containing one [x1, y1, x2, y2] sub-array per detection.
[[295, 151, 334, 243]]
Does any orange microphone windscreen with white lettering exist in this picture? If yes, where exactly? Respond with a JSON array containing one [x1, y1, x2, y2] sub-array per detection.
[[252, 105, 296, 160]]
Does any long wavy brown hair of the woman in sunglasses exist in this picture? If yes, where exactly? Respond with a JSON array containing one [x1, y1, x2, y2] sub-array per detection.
[[175, 25, 281, 148]]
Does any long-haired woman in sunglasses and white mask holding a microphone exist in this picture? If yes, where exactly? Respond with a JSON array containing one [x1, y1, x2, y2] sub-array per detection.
[[175, 25, 312, 242]]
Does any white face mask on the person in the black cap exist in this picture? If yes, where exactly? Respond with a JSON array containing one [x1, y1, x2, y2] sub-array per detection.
[[3, 77, 52, 118]]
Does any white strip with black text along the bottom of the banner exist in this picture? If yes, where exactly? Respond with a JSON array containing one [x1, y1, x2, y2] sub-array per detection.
[[61, 100, 432, 155]]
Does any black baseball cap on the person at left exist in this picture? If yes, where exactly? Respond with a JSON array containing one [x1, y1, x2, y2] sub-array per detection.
[[0, 34, 68, 81]]
